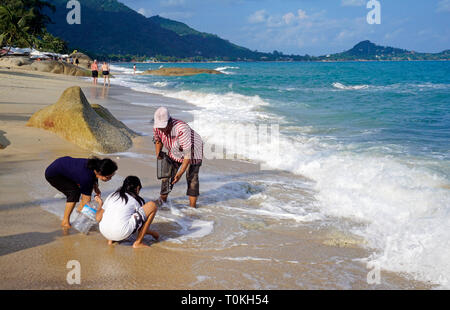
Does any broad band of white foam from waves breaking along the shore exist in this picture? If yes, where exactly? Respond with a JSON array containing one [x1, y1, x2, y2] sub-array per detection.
[[177, 88, 450, 287]]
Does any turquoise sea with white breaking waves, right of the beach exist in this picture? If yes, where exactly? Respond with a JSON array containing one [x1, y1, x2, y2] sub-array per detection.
[[112, 62, 450, 288]]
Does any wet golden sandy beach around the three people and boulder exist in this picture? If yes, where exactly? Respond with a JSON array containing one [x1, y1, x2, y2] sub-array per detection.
[[0, 69, 432, 290]]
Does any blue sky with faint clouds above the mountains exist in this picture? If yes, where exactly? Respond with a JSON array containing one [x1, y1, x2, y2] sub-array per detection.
[[119, 0, 450, 56]]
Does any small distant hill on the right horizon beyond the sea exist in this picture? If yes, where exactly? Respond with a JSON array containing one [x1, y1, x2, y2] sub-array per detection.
[[318, 40, 450, 61]]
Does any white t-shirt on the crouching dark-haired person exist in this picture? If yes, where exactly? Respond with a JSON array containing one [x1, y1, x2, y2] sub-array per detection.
[[99, 193, 141, 241]]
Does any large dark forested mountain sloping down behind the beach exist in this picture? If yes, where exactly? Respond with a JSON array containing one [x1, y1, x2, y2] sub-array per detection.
[[46, 0, 264, 60]]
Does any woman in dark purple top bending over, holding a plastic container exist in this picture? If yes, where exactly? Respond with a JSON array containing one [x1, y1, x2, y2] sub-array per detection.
[[45, 156, 117, 228]]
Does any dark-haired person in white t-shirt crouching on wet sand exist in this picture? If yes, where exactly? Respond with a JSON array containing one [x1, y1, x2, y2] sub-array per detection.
[[96, 176, 159, 248]]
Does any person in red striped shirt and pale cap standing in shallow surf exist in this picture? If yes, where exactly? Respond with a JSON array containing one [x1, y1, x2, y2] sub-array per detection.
[[153, 107, 203, 208]]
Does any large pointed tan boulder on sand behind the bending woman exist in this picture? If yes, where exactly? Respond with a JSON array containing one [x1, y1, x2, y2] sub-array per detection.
[[27, 86, 136, 154]]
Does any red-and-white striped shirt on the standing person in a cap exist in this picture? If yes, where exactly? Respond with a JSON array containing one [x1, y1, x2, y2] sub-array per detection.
[[153, 118, 203, 165]]
